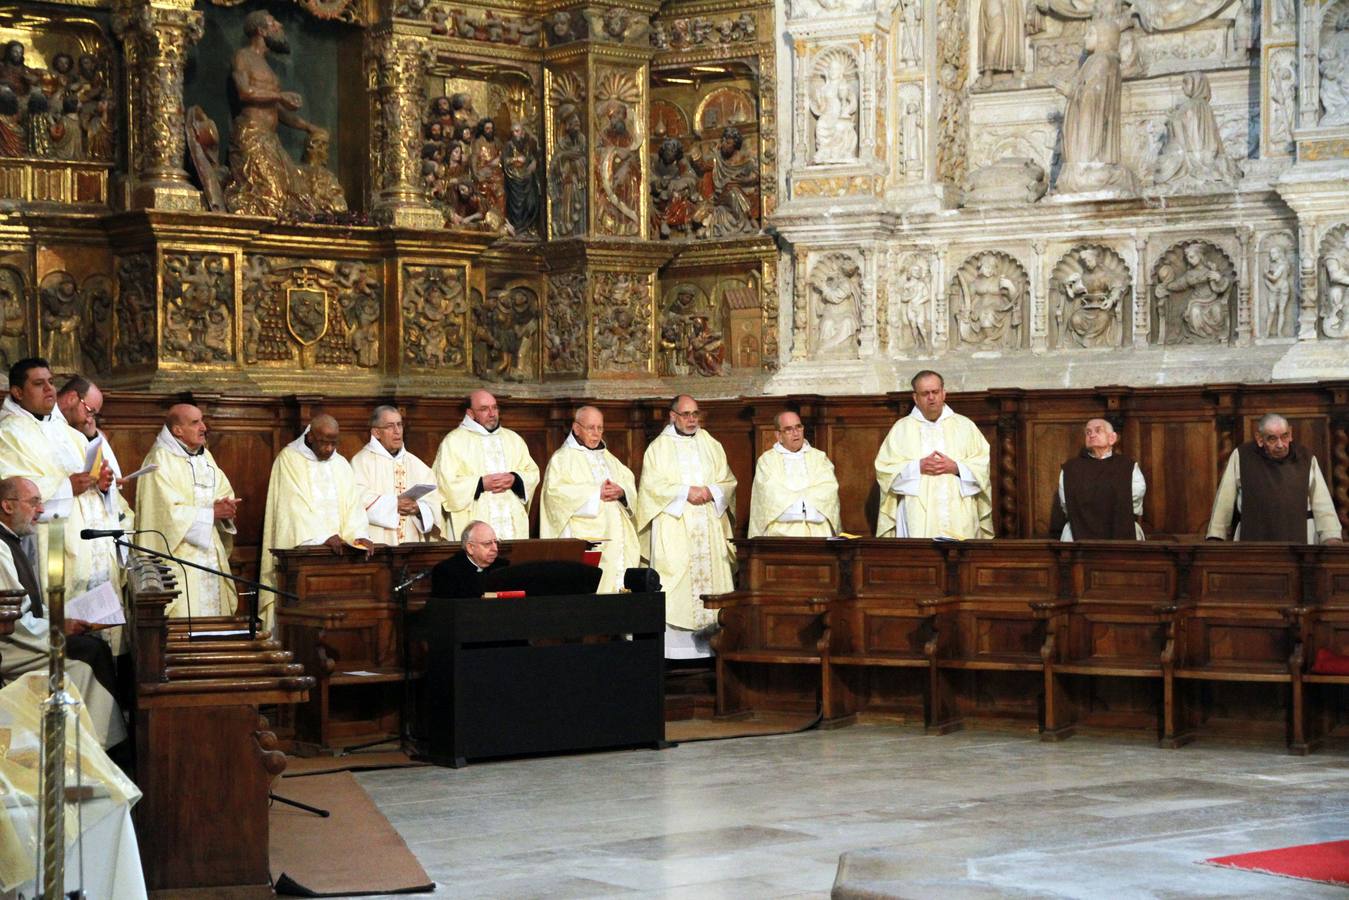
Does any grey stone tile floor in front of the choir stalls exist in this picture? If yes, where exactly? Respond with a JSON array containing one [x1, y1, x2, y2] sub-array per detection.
[[359, 725, 1349, 900]]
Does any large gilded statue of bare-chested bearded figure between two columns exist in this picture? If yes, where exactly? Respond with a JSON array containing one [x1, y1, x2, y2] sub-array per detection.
[[225, 9, 326, 219]]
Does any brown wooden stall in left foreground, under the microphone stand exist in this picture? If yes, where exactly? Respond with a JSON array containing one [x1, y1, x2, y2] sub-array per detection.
[[128, 556, 314, 897]]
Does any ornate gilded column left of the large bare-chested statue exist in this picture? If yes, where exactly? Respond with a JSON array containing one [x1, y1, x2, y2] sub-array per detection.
[[112, 0, 202, 209]]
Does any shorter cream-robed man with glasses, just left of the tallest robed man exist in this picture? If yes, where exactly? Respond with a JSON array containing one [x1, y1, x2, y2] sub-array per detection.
[[749, 412, 839, 537]]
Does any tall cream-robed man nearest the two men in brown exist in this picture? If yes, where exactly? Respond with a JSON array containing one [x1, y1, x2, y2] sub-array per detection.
[[876, 370, 993, 541]]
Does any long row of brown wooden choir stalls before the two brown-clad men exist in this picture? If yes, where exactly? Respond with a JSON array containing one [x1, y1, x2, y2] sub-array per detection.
[[706, 538, 1349, 753]]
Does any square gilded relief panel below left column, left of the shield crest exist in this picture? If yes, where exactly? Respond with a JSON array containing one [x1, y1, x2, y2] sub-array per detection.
[[161, 252, 235, 363]]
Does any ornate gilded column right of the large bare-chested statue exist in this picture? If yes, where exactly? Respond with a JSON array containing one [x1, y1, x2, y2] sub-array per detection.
[[366, 23, 445, 229]]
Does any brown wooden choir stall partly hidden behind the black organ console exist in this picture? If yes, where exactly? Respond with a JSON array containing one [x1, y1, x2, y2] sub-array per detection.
[[272, 538, 587, 754]]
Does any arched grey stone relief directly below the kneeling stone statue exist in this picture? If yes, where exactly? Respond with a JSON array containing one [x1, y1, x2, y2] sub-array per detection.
[[1152, 240, 1237, 344]]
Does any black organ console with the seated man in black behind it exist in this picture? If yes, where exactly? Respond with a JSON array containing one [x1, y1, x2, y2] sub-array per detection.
[[415, 591, 665, 768]]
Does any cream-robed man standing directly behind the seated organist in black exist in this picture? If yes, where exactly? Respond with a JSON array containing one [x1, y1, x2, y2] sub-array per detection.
[[432, 390, 538, 541]]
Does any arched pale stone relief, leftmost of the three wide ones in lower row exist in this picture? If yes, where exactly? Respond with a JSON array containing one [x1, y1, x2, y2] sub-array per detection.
[[946, 251, 1031, 349]]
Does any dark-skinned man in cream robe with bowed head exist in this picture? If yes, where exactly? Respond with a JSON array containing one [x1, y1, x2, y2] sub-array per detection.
[[258, 414, 374, 629]]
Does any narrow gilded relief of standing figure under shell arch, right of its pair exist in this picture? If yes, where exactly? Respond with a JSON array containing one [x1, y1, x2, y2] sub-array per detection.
[[594, 66, 645, 237]]
